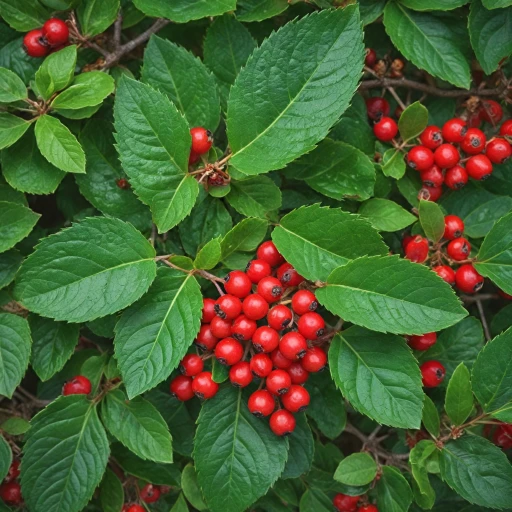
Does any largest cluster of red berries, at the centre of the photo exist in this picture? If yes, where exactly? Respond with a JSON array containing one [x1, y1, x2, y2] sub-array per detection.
[[170, 241, 327, 436]]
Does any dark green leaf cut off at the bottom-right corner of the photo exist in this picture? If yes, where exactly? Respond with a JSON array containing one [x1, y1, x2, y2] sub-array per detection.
[[439, 435, 512, 509]]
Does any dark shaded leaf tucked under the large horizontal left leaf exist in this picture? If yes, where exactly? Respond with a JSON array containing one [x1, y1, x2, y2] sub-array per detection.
[[29, 315, 80, 381]]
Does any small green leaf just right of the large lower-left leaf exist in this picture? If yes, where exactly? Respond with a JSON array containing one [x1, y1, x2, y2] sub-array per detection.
[[101, 389, 172, 463]]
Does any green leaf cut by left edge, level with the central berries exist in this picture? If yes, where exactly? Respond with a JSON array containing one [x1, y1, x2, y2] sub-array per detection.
[[0, 313, 32, 398]]
